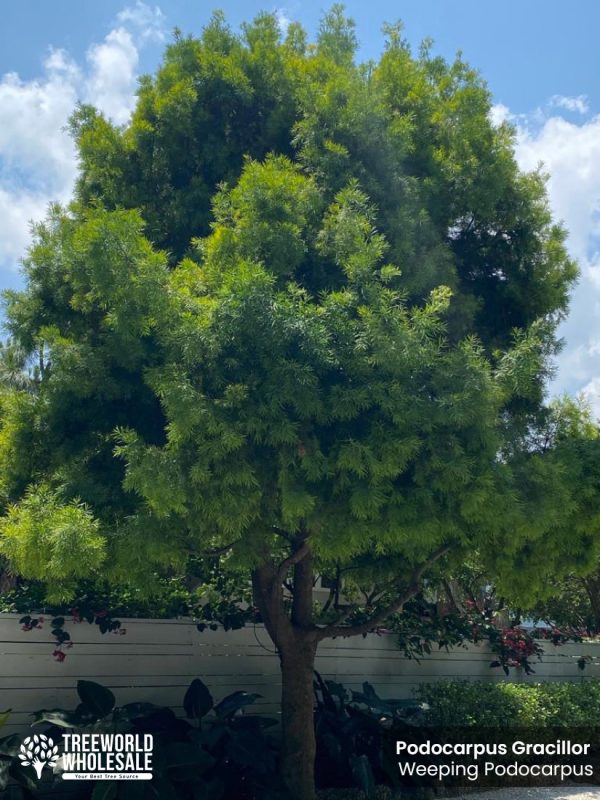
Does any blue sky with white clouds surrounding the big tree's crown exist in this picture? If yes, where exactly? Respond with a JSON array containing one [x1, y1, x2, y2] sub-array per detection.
[[0, 0, 600, 406]]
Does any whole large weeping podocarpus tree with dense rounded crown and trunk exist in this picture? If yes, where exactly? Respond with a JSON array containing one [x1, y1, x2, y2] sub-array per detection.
[[0, 6, 576, 800]]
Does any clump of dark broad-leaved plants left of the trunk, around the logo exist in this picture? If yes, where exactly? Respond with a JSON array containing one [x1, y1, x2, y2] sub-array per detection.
[[29, 678, 285, 800]]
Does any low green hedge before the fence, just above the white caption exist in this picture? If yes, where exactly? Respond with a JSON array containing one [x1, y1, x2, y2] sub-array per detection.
[[417, 680, 600, 727]]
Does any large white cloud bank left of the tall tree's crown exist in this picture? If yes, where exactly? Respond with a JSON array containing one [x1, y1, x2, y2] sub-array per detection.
[[0, 2, 164, 273]]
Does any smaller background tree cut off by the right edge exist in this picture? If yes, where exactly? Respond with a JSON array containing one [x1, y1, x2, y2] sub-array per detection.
[[487, 397, 600, 634]]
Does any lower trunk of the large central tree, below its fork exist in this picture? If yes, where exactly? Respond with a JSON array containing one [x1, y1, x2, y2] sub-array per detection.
[[280, 633, 317, 800]]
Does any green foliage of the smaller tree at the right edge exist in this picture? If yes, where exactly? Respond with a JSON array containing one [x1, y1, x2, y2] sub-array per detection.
[[480, 398, 600, 609]]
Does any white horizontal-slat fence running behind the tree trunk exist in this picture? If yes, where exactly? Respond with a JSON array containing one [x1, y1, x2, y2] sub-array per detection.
[[0, 614, 600, 735]]
